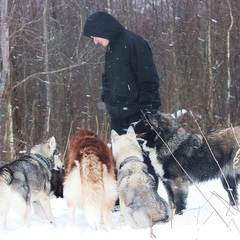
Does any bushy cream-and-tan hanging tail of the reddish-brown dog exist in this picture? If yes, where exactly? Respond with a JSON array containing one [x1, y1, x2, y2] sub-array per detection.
[[80, 154, 105, 229]]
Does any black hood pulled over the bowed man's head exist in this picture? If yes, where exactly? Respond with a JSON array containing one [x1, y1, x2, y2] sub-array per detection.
[[83, 12, 125, 42]]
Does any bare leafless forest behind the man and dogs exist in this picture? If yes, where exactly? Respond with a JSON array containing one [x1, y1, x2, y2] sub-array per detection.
[[0, 0, 240, 161]]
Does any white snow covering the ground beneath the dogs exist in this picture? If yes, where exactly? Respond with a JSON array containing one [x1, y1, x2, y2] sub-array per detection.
[[0, 180, 240, 240]]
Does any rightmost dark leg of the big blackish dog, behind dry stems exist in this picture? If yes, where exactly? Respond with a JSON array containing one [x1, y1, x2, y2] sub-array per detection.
[[221, 175, 239, 206]]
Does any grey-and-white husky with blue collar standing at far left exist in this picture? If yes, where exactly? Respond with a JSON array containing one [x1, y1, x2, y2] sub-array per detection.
[[0, 137, 58, 228]]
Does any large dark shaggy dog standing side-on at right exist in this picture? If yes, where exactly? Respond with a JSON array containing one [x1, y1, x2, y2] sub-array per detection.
[[135, 113, 240, 214]]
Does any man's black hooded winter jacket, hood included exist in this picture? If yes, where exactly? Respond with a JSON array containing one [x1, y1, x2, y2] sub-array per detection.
[[84, 12, 161, 120]]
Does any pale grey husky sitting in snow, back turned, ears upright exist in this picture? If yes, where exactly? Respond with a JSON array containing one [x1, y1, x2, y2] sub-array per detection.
[[111, 126, 171, 229]]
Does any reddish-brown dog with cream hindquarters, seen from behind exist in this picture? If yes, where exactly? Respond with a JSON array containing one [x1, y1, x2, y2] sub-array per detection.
[[63, 129, 117, 229]]
